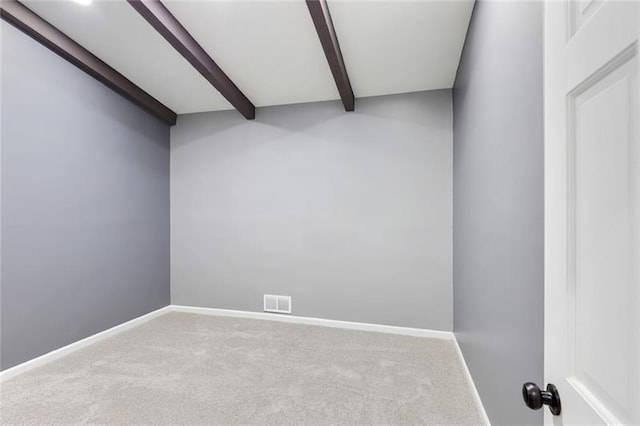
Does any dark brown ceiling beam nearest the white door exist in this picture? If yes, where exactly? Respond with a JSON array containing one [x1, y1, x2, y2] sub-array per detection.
[[306, 0, 355, 111]]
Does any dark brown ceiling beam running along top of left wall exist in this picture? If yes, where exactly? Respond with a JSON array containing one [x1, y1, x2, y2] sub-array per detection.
[[0, 0, 176, 126]]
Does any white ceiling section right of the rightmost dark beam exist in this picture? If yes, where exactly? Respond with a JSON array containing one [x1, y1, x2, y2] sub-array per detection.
[[328, 0, 473, 97]]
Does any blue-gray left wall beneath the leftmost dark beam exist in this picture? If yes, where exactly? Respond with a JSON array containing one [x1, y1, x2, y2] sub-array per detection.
[[0, 22, 170, 369]]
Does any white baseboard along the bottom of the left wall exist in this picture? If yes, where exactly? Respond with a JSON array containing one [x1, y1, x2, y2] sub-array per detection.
[[0, 306, 171, 383]]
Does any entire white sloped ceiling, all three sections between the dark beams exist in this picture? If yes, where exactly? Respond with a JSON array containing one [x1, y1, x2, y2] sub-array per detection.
[[22, 0, 473, 114]]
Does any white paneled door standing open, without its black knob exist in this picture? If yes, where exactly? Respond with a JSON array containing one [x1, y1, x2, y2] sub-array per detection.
[[545, 0, 640, 425]]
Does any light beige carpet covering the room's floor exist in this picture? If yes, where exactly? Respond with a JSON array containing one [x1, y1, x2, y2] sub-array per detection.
[[0, 312, 481, 425]]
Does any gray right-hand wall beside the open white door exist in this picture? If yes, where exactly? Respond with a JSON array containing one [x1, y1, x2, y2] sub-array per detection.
[[453, 0, 544, 425]]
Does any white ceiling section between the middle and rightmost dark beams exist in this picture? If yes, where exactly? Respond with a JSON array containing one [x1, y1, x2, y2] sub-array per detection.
[[164, 0, 340, 106]]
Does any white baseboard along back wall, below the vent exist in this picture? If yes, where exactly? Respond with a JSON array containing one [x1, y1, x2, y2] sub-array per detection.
[[170, 305, 455, 340]]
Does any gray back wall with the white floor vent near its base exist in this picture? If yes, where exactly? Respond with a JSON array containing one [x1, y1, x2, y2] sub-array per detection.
[[171, 90, 453, 330]]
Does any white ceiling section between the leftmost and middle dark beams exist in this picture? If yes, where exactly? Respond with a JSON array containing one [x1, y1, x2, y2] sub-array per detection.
[[23, 0, 233, 113]]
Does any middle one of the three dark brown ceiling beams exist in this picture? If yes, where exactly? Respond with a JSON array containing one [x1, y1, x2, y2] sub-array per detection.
[[127, 0, 256, 120]]
